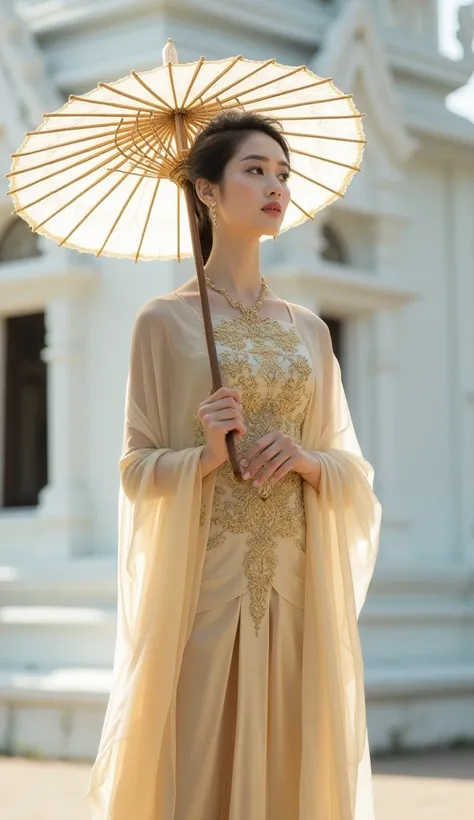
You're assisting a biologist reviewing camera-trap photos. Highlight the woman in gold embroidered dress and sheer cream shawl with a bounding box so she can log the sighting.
[89,112,380,820]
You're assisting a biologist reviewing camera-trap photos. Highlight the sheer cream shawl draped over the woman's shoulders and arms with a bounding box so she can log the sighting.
[88,294,380,820]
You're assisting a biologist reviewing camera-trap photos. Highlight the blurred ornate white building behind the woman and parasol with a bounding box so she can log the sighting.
[0,0,474,820]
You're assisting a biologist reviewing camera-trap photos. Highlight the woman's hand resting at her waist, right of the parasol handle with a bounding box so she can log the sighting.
[240,430,321,489]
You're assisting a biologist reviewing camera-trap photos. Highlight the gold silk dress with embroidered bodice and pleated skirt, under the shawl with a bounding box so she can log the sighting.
[174,315,314,820]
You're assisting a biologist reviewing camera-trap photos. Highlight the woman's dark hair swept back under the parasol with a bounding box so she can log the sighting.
[186,109,290,264]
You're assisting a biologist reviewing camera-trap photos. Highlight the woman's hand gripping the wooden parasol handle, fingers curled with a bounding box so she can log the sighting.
[198,387,245,478]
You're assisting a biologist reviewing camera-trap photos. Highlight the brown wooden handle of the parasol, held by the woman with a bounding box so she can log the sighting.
[175,114,242,480]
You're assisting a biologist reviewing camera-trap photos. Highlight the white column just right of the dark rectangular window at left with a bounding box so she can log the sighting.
[39,294,91,556]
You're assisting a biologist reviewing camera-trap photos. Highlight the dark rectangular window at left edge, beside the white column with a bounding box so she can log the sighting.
[3,313,47,507]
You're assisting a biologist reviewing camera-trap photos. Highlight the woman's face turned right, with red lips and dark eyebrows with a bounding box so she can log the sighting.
[215,131,290,237]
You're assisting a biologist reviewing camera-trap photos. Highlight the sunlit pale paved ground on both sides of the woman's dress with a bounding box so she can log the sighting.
[0,750,474,820]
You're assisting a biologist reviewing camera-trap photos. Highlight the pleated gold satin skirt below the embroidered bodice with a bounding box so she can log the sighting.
[174,587,304,820]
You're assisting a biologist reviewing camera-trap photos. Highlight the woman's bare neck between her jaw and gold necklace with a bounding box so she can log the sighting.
[205,232,262,299]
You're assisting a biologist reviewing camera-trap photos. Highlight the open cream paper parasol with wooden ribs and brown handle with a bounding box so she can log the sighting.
[7,40,366,478]
